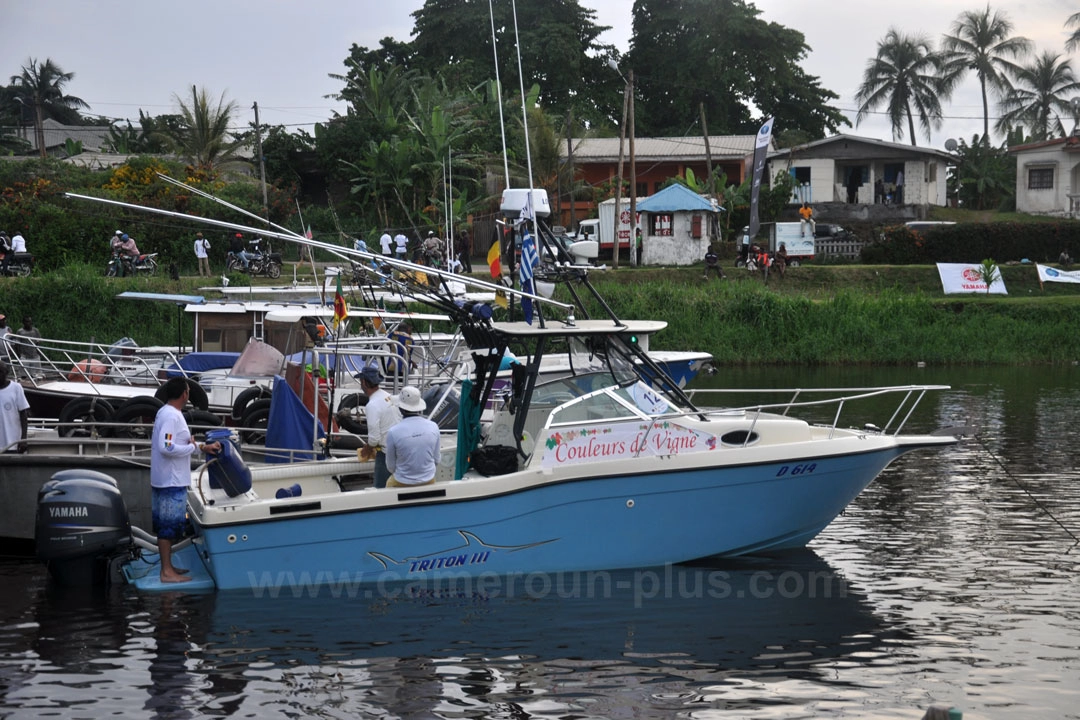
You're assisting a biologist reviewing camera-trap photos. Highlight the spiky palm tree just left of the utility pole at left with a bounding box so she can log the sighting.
[171,85,247,177]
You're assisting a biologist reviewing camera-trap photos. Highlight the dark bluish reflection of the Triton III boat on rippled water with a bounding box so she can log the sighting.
[120,551,881,717]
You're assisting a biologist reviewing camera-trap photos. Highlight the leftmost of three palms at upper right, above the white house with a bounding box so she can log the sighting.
[855,28,953,145]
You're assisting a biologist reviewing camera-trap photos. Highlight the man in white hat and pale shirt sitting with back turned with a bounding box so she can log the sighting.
[387,385,442,488]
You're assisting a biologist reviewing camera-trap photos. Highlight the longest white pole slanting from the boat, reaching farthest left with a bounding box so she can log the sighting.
[65,192,575,320]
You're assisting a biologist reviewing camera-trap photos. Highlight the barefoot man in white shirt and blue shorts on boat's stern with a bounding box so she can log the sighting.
[150,378,221,583]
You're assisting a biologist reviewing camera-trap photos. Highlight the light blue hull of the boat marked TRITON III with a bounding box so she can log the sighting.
[179,446,914,595]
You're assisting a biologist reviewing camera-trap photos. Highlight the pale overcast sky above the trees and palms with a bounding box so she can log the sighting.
[0,0,1080,148]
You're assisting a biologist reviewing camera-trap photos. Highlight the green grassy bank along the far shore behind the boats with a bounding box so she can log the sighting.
[8,266,1080,365]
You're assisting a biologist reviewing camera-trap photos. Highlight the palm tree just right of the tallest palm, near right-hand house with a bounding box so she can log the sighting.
[995,51,1080,140]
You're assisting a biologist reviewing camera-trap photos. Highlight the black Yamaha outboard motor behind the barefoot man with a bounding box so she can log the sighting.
[35,470,132,585]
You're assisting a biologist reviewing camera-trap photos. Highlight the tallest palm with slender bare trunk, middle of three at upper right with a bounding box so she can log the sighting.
[942,5,1031,145]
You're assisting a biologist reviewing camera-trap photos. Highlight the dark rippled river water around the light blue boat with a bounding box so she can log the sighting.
[0,367,1080,719]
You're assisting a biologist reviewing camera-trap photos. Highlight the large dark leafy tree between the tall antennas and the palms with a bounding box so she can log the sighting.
[630,0,850,138]
